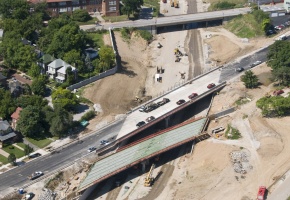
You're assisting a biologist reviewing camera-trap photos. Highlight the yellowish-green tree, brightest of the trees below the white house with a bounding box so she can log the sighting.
[51,88,78,111]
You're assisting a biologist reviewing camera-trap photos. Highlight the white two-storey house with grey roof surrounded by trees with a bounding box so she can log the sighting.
[46,59,77,83]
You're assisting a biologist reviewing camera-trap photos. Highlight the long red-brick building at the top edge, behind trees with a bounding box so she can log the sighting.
[28,0,120,16]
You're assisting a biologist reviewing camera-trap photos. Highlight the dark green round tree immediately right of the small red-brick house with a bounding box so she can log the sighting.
[16,105,44,138]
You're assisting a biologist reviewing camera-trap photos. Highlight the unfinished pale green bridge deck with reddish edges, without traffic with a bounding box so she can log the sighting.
[79,118,207,191]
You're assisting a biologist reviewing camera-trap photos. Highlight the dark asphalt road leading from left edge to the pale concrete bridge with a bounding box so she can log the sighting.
[0,120,124,197]
